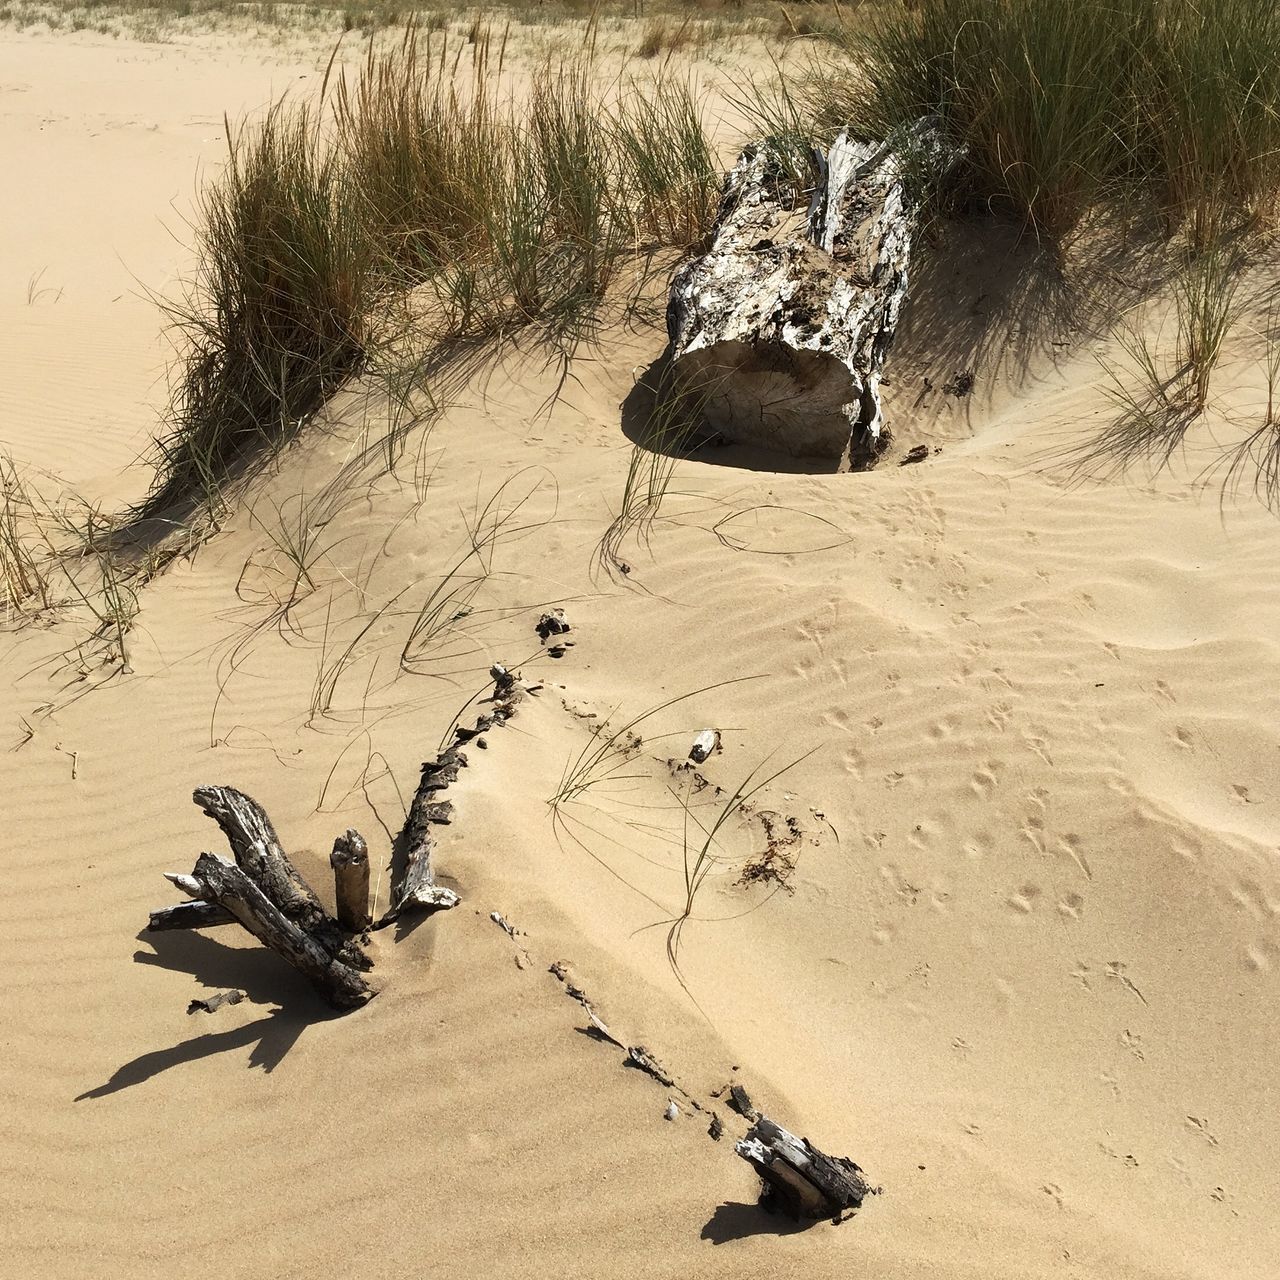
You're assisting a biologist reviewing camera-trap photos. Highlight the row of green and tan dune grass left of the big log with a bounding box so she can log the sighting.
[136,24,719,522]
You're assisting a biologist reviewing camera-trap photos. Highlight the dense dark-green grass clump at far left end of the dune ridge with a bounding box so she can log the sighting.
[140,104,372,517]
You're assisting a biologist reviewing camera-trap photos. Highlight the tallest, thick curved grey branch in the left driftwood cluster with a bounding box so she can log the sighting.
[179,786,362,964]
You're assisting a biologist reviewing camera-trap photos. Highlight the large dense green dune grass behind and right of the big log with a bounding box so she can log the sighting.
[809,0,1280,244]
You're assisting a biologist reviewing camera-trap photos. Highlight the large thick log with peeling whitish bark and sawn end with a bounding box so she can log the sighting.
[667,120,940,468]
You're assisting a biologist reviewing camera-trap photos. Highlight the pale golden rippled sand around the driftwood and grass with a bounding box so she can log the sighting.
[0,20,1280,1280]
